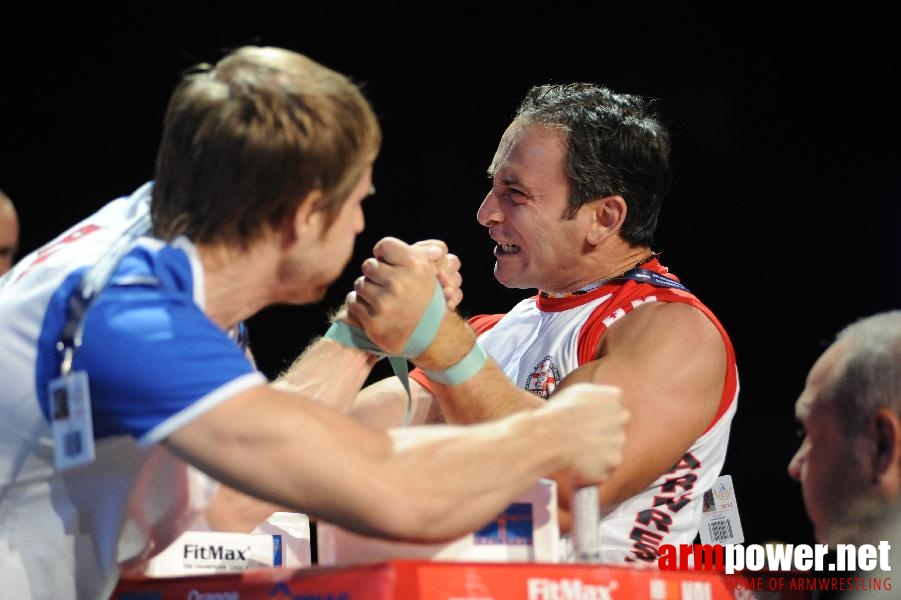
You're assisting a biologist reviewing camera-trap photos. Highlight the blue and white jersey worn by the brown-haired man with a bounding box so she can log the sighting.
[0,184,266,598]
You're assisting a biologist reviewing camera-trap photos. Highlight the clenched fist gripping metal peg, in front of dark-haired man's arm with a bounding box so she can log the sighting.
[539,383,629,485]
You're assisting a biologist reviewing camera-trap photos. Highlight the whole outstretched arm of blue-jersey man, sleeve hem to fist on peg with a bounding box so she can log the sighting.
[165,386,626,541]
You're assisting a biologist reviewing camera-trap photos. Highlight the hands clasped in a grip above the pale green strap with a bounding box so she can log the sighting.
[347,237,454,354]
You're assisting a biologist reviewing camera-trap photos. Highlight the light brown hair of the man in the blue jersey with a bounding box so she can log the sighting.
[152,47,381,248]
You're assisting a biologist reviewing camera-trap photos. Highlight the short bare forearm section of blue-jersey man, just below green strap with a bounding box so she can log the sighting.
[272,339,377,413]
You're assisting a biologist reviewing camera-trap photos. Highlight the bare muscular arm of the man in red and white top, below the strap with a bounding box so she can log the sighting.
[420,303,726,527]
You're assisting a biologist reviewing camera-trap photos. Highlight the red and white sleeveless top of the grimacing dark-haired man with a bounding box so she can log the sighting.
[414,259,738,565]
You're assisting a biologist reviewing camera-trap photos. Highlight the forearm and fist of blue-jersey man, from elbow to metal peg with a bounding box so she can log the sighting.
[376,385,628,535]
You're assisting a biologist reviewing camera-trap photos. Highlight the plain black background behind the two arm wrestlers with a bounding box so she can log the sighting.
[0,9,901,543]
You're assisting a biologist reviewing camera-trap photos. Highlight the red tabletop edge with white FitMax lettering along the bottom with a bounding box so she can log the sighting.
[112,560,824,600]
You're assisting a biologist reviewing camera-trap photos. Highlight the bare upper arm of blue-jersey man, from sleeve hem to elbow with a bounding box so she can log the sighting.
[166,386,391,528]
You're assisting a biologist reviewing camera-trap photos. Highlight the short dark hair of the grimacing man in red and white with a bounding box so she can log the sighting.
[516,83,672,246]
